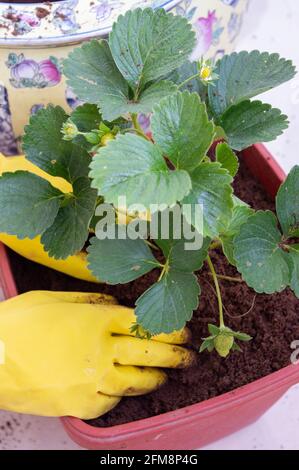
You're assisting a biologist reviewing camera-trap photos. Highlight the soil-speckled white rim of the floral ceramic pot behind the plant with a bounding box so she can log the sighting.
[0,0,180,48]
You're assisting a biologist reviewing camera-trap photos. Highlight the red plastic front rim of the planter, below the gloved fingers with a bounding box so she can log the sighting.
[60,364,299,442]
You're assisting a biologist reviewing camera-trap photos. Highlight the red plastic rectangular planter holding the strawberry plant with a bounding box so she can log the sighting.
[0,145,299,450]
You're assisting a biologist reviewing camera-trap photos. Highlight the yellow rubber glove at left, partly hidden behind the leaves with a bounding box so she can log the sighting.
[0,154,99,283]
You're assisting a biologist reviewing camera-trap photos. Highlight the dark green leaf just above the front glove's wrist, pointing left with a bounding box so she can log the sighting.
[87,237,159,284]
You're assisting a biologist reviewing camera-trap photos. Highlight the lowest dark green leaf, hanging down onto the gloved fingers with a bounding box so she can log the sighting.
[135,270,200,335]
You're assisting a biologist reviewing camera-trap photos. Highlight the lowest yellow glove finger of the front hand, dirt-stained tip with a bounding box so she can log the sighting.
[98,364,167,397]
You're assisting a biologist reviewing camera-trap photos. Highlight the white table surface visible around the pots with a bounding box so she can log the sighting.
[0,0,299,450]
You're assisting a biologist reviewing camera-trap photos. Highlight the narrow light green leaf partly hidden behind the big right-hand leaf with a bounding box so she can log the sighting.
[220,205,254,266]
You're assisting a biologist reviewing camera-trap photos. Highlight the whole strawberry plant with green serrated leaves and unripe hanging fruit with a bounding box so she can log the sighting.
[0,9,299,357]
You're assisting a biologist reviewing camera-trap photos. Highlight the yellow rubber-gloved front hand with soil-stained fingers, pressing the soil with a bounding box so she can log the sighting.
[0,291,193,419]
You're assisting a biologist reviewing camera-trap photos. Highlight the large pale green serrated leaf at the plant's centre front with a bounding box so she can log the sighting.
[90,134,191,208]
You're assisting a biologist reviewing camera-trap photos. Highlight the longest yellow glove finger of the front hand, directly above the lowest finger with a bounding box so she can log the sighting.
[114,336,195,369]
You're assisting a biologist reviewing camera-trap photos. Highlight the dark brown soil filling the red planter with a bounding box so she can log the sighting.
[10,157,299,426]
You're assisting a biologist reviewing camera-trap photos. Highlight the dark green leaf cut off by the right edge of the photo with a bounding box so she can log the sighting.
[276,166,299,238]
